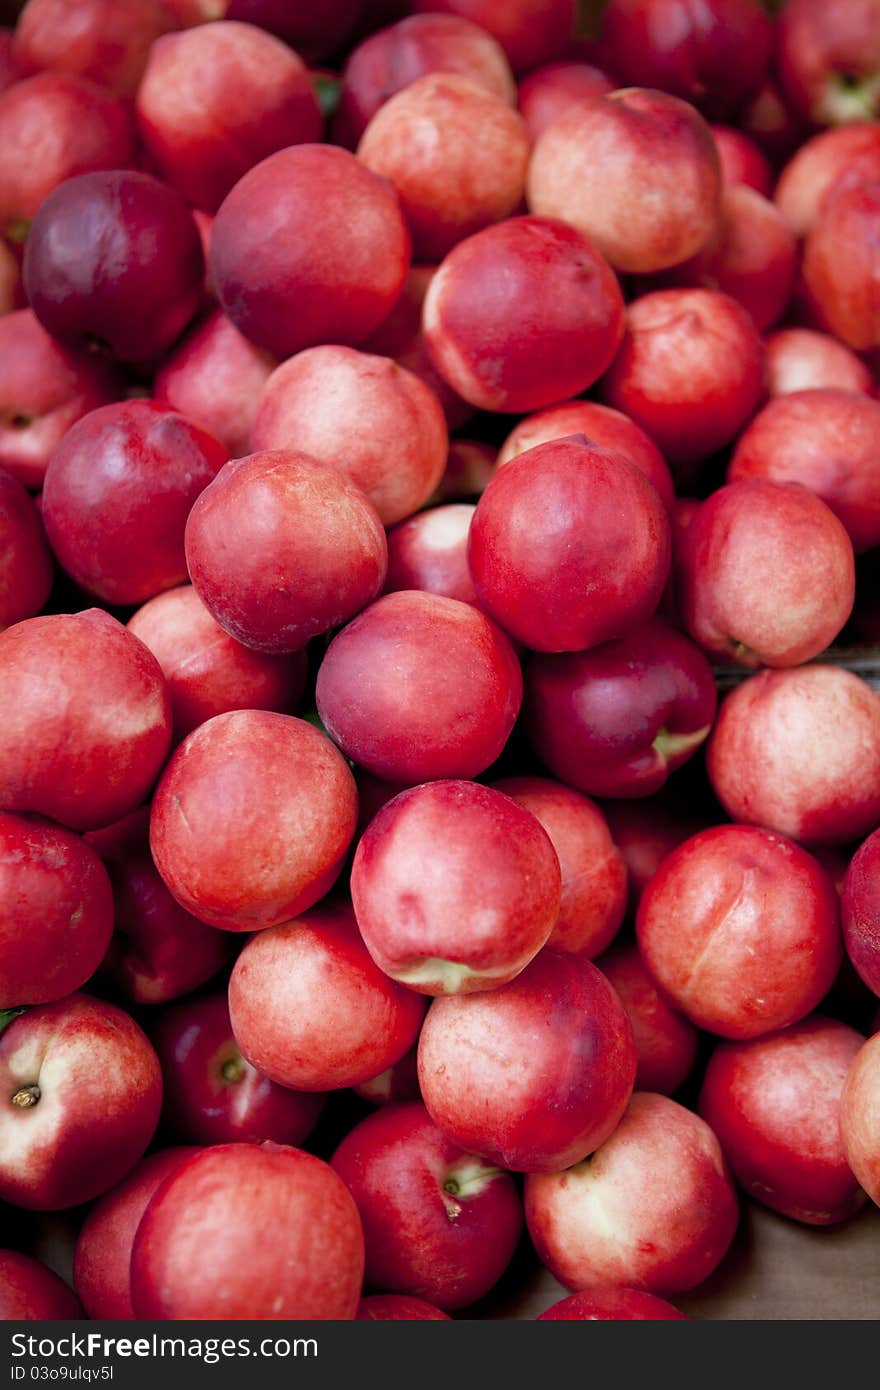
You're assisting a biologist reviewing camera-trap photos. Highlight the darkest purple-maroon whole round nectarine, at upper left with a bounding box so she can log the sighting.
[24,171,204,361]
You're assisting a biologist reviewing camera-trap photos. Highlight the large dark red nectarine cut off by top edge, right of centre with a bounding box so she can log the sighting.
[602,0,773,115]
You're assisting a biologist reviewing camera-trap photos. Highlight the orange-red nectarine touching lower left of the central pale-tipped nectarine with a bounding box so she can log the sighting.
[229,901,425,1091]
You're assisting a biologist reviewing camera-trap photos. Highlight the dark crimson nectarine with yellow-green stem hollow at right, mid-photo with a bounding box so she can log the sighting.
[524,620,717,796]
